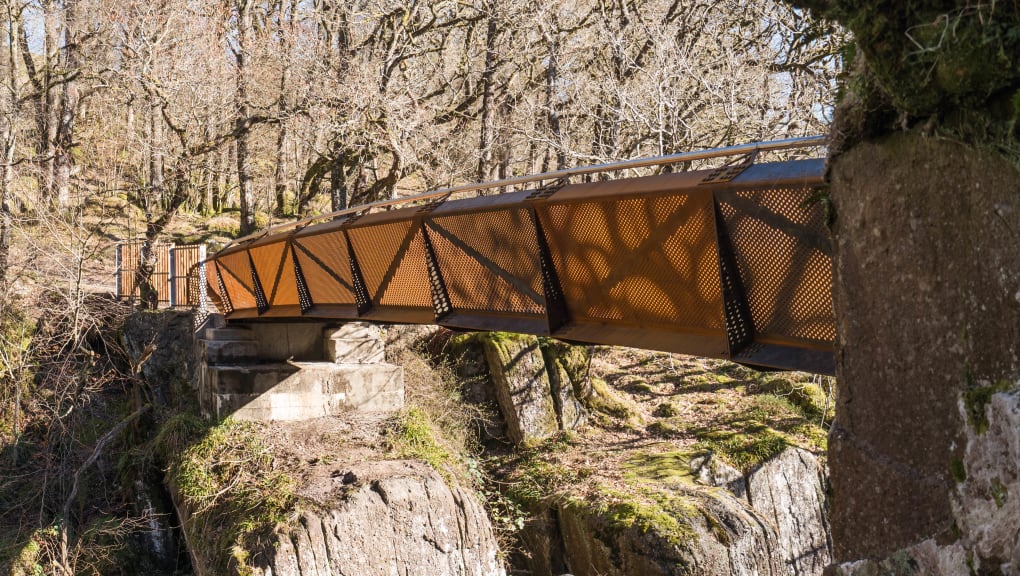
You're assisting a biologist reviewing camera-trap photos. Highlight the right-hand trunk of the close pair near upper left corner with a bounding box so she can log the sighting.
[53,0,81,208]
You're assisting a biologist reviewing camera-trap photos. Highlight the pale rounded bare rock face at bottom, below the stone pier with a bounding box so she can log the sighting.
[250,462,505,576]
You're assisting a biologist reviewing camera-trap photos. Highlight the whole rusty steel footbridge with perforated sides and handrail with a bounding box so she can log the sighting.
[200,138,835,374]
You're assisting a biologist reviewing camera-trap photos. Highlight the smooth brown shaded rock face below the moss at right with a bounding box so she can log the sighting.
[828,134,1020,562]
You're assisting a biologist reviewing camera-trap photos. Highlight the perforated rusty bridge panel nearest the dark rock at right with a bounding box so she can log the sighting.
[720,189,835,343]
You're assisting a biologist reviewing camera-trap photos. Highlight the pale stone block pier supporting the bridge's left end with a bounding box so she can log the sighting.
[197,316,404,421]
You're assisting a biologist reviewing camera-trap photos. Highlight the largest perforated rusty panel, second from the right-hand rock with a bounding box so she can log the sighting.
[540,193,725,331]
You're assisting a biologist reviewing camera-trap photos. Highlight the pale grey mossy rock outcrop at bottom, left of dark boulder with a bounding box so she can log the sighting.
[523,449,831,576]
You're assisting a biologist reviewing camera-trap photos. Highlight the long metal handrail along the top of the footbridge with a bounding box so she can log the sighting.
[221,136,827,251]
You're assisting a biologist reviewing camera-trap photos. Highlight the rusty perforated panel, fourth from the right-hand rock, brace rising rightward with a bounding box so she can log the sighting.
[348,220,432,309]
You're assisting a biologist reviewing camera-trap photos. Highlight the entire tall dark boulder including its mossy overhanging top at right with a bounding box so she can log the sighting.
[793,0,1020,565]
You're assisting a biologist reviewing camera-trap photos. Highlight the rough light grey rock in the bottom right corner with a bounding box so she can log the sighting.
[828,381,1020,576]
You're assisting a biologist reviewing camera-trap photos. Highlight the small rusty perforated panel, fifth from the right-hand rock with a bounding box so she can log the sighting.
[294,230,355,305]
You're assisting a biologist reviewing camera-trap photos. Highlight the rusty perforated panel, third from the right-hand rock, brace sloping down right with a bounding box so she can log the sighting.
[428,209,545,315]
